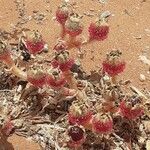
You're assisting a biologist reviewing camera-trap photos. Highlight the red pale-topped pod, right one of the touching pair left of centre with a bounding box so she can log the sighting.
[46,69,66,90]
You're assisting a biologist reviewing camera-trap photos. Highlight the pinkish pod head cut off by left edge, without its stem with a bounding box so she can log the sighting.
[0,40,12,64]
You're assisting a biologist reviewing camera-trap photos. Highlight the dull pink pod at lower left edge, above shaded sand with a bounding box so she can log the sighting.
[1,120,14,136]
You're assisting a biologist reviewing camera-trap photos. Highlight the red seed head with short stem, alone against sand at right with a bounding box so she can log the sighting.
[102,50,125,84]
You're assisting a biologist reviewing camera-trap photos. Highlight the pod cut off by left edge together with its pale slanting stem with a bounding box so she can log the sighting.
[0,40,27,80]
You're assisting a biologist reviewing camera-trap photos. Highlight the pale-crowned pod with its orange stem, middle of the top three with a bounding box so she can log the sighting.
[65,13,83,47]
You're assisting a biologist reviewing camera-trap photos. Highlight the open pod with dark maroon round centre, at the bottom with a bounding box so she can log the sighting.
[67,125,86,148]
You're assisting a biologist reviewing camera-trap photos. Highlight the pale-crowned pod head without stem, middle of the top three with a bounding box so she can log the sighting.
[65,13,83,37]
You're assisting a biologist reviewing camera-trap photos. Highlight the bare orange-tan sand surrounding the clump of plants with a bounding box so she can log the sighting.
[0,0,150,150]
